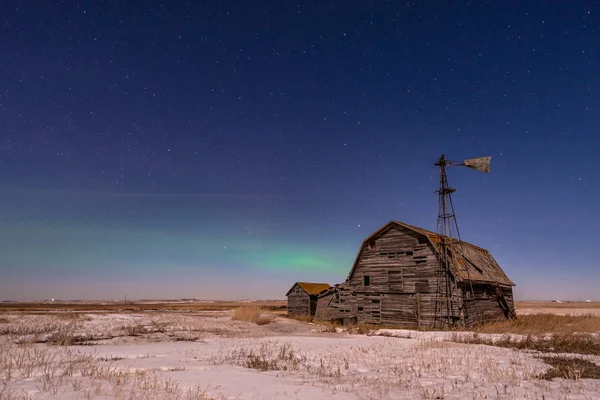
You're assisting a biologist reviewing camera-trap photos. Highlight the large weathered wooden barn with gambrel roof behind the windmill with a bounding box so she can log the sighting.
[315,221,515,327]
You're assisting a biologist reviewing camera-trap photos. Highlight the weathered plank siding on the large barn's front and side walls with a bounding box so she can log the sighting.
[316,226,514,327]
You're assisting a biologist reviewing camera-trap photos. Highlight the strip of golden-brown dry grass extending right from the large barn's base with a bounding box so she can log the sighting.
[476,314,600,335]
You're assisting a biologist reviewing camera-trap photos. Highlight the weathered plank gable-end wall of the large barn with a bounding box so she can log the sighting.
[317,227,461,327]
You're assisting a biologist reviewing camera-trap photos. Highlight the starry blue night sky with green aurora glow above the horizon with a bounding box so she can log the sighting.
[0,0,600,300]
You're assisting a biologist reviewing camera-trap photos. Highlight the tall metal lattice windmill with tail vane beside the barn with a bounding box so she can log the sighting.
[434,154,492,326]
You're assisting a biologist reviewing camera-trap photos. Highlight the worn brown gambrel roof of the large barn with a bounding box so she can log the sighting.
[349,221,515,286]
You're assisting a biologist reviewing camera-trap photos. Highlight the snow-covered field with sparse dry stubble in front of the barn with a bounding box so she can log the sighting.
[0,311,600,400]
